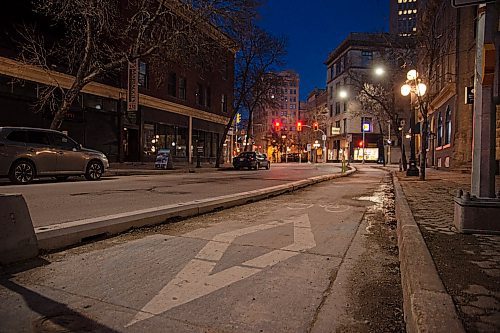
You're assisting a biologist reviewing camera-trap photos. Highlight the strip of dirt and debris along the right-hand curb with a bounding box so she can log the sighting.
[341,177,405,332]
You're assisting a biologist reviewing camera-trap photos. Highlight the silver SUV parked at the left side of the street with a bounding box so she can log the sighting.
[0,127,109,184]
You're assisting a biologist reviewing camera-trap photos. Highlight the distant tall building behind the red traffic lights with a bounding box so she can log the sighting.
[253,70,300,160]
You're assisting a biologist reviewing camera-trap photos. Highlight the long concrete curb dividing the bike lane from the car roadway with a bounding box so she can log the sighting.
[35,167,357,250]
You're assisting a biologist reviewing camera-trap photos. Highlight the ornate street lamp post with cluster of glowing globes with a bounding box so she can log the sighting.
[401,69,427,178]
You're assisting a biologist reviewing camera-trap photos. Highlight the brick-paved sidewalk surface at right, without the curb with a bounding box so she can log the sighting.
[390,167,500,332]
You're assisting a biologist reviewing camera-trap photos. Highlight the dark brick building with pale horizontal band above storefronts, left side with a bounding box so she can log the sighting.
[0,0,234,162]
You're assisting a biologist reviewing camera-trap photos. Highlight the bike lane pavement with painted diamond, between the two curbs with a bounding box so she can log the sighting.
[0,167,404,332]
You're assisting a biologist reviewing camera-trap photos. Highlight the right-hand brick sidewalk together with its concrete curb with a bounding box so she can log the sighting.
[387,167,500,332]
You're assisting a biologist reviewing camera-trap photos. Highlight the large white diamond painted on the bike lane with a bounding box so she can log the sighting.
[125,214,316,327]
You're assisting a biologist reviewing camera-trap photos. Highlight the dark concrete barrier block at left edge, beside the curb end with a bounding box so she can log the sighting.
[0,194,38,265]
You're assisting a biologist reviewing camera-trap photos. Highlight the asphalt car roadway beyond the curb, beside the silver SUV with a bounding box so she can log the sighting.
[0,164,340,227]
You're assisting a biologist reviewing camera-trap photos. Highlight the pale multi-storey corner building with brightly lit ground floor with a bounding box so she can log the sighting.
[325,33,400,161]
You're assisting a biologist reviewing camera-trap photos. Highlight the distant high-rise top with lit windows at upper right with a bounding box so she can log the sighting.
[389,0,418,36]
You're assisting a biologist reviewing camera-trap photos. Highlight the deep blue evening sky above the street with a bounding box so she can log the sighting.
[260,0,389,101]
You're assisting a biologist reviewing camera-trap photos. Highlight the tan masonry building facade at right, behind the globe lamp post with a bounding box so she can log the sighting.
[417,1,477,169]
